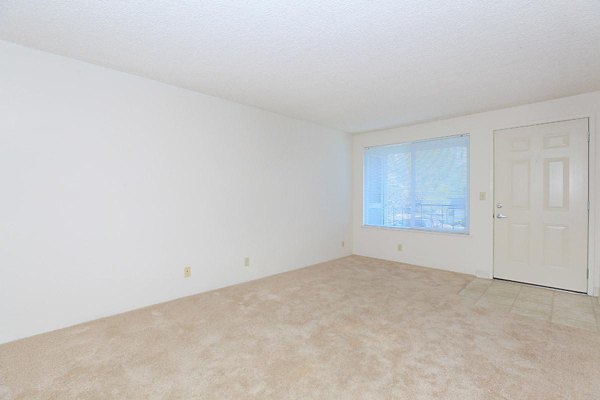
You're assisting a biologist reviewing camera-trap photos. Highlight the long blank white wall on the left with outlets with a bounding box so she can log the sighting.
[0,42,352,342]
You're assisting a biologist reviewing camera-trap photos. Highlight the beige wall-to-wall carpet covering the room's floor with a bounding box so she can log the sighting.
[0,256,600,400]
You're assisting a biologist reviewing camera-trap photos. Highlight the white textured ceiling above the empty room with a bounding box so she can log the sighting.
[0,0,600,132]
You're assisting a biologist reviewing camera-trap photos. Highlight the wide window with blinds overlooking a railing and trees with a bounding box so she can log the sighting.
[363,135,469,233]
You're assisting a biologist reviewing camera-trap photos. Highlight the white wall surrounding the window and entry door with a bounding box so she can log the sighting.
[353,92,600,295]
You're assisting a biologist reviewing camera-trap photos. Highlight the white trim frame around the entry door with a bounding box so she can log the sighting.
[491,115,600,294]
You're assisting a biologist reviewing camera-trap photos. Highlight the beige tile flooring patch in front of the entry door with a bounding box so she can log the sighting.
[459,278,600,332]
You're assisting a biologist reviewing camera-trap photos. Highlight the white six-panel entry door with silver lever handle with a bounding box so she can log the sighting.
[494,118,589,292]
